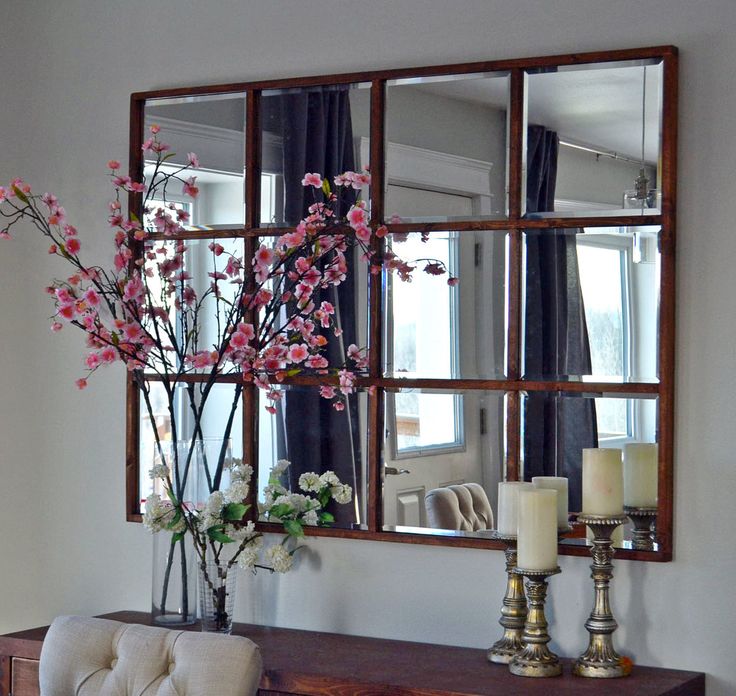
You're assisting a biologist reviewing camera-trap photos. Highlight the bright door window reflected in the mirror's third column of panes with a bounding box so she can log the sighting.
[387,232,463,456]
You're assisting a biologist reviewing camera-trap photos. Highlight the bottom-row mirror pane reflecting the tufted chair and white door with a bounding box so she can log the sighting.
[383,389,505,536]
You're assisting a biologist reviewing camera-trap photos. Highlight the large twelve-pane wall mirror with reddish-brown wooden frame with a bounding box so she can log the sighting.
[128,47,677,560]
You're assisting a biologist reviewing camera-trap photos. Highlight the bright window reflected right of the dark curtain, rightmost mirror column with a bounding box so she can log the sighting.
[577,231,633,441]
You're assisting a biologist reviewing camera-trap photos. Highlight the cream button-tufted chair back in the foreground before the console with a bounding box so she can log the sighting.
[39,616,263,696]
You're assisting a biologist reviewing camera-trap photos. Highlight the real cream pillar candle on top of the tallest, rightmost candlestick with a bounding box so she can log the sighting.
[583,448,624,515]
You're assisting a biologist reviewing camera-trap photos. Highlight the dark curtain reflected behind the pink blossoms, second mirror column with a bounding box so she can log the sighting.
[280,86,362,527]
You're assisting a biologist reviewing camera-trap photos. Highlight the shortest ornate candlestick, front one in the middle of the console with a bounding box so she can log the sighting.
[509,567,562,677]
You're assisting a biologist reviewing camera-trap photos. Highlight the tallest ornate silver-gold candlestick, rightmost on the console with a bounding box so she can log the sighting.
[573,513,630,679]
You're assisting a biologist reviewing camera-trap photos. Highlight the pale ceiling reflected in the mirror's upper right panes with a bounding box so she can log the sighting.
[416,64,662,163]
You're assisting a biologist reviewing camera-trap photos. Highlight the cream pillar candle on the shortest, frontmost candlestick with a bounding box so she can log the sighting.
[516,488,557,570]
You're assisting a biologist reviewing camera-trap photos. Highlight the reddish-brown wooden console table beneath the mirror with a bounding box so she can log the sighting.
[0,611,705,696]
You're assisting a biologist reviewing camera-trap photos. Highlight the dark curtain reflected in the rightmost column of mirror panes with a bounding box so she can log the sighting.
[524,126,598,511]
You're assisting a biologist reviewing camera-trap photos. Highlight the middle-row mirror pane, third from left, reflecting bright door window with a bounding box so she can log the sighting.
[384,230,508,379]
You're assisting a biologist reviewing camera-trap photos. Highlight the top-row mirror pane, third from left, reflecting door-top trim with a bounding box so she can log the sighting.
[385,73,509,222]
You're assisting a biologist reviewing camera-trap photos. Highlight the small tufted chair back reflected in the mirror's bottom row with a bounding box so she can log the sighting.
[424,483,493,532]
